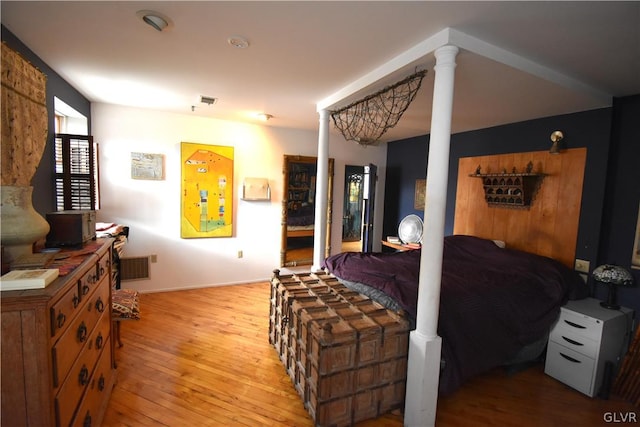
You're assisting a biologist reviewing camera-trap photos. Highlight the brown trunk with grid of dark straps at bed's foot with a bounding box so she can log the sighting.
[269,270,409,426]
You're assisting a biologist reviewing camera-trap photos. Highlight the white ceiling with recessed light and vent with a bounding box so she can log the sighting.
[0,0,640,144]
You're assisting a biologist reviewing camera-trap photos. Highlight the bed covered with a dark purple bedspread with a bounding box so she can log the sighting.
[323,235,588,395]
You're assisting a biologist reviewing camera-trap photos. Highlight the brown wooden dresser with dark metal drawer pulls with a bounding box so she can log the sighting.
[0,238,116,427]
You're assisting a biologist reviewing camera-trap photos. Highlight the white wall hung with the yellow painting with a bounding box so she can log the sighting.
[92,104,386,292]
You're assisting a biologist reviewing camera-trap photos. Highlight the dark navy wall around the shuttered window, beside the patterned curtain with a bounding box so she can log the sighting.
[2,25,91,216]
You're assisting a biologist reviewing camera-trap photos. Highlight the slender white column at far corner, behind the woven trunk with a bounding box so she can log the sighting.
[311,110,329,271]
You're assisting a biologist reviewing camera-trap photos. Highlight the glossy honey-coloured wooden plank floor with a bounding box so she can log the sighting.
[103,282,640,427]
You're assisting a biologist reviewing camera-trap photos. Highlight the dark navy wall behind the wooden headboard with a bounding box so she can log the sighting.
[383,97,640,310]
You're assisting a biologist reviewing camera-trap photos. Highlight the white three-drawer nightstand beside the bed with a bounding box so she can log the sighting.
[544,298,633,397]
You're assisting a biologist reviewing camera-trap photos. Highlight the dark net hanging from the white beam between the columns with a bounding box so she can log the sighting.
[331,70,427,145]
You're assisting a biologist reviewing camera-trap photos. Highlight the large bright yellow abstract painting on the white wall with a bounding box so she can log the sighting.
[180,142,233,238]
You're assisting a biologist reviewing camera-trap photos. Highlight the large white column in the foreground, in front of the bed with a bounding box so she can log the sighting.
[404,46,458,427]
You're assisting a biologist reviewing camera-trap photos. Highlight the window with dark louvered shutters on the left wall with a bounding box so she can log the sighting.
[55,133,100,211]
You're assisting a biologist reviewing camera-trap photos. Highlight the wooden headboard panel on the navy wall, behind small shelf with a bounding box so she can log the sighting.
[453,148,587,268]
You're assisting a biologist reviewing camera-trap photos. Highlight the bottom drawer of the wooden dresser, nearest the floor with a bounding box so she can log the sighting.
[72,339,114,427]
